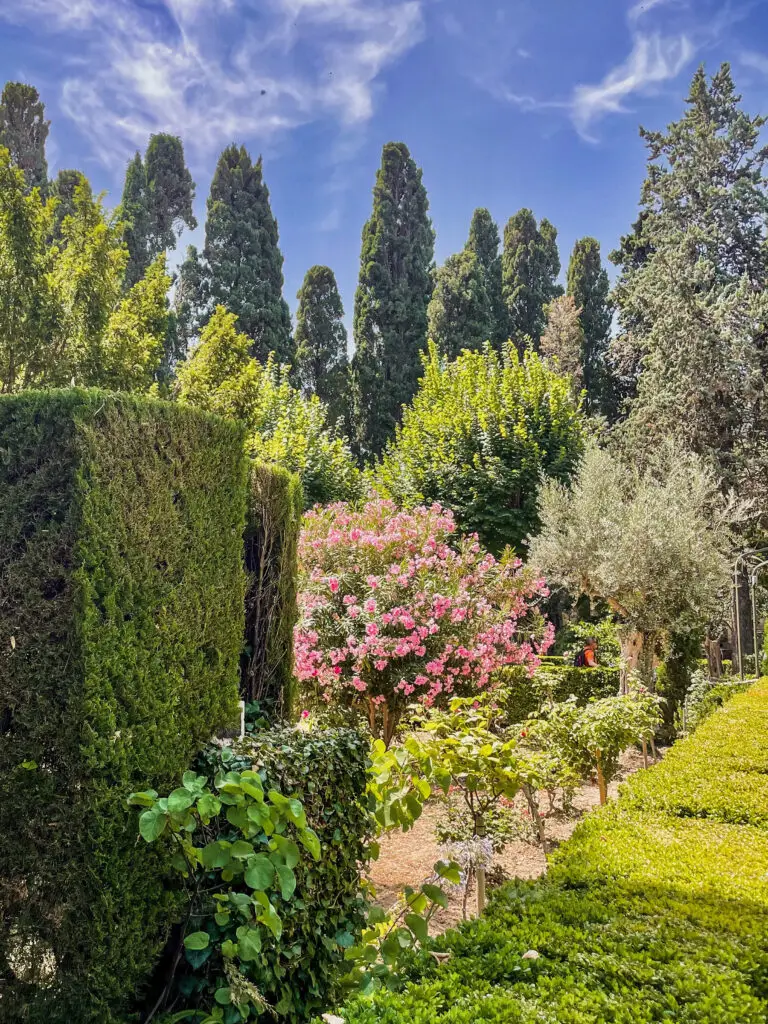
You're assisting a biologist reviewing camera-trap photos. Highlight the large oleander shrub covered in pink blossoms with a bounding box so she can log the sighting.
[295,500,552,743]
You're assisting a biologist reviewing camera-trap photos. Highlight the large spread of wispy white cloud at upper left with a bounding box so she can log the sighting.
[0,0,423,167]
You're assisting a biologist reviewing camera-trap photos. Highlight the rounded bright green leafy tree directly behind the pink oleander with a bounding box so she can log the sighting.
[377,344,584,552]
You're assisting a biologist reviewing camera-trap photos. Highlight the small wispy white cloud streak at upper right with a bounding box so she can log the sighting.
[568,33,695,138]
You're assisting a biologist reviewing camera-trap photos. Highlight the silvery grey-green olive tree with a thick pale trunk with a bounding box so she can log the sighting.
[530,445,739,686]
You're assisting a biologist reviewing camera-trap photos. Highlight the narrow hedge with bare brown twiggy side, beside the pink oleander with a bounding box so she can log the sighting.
[241,463,304,719]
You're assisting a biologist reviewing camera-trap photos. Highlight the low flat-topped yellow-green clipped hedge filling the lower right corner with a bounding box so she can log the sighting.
[331,682,768,1024]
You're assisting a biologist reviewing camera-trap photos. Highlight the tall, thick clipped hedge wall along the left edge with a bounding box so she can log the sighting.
[0,390,246,1024]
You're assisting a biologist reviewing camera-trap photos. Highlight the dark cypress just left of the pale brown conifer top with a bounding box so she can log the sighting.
[502,209,562,348]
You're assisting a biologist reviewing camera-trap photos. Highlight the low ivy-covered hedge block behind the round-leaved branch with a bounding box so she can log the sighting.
[143,729,373,1022]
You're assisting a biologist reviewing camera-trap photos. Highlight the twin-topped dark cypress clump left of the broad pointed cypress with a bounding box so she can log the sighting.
[120,134,198,288]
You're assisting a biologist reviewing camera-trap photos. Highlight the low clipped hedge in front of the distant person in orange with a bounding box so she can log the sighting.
[494,663,620,722]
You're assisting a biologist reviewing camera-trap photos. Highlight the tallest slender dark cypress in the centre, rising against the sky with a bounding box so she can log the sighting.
[352,142,434,456]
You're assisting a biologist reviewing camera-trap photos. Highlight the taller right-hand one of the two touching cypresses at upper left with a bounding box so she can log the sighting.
[144,134,198,260]
